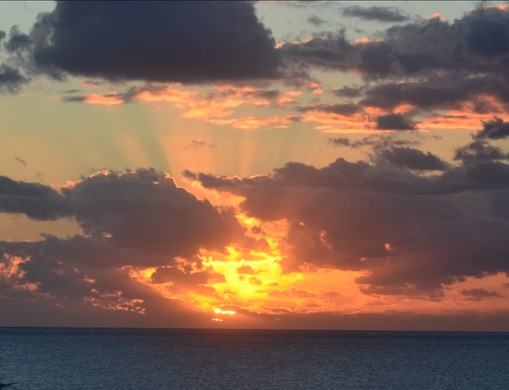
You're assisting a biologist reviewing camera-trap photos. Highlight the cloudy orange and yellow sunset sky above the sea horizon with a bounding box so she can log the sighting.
[0,1,509,331]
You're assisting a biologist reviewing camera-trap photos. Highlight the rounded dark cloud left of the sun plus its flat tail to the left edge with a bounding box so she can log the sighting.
[0,169,241,256]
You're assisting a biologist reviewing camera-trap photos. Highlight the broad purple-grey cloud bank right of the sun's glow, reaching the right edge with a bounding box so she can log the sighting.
[189,148,509,299]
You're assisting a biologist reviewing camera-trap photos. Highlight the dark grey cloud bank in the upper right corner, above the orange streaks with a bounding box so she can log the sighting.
[278,6,509,122]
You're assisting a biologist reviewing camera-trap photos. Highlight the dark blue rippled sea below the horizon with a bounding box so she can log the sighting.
[0,328,509,390]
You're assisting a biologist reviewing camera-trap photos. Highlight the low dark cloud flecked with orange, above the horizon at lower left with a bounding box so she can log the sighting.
[0,236,212,326]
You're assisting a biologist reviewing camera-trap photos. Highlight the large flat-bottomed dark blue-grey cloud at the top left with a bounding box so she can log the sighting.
[5,1,279,83]
